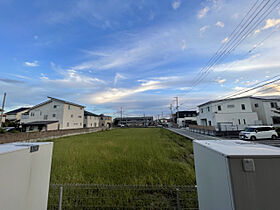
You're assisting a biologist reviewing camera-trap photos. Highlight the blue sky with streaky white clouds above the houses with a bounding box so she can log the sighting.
[0,0,280,117]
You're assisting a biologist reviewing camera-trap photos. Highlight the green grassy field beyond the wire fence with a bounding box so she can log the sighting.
[51,128,195,185]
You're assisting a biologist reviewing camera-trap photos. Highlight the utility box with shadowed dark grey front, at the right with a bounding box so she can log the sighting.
[193,140,280,210]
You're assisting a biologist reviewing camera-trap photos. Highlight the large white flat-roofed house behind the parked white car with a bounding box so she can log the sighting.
[198,96,280,130]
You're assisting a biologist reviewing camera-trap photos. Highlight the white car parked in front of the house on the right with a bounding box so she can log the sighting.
[239,126,278,141]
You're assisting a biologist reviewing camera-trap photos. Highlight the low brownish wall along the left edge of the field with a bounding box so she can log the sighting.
[0,127,108,144]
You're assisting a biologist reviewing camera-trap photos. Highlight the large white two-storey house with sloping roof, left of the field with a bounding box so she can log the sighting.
[21,97,85,130]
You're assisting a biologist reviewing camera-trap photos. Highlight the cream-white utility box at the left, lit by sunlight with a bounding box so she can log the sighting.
[0,142,53,210]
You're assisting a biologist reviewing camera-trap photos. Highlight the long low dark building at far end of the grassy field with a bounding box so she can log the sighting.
[114,116,154,127]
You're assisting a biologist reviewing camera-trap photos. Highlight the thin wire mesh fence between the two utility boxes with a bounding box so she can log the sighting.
[48,184,198,210]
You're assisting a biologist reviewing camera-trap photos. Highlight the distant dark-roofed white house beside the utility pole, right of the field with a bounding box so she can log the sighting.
[174,111,197,127]
